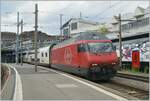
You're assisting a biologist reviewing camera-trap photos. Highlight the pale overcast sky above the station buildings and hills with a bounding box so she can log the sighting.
[1,0,149,35]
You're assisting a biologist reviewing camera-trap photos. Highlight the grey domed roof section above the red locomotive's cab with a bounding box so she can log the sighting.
[73,32,108,41]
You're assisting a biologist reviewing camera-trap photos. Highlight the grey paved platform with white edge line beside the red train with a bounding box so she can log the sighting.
[7,64,126,100]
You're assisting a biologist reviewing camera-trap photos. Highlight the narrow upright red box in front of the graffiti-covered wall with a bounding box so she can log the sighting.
[132,50,140,69]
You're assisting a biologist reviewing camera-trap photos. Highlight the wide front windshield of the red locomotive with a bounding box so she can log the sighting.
[88,42,113,53]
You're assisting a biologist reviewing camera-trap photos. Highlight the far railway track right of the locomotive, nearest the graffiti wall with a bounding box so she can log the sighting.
[116,73,149,83]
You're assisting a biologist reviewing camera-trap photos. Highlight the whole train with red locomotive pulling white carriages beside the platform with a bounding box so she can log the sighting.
[24,32,118,80]
